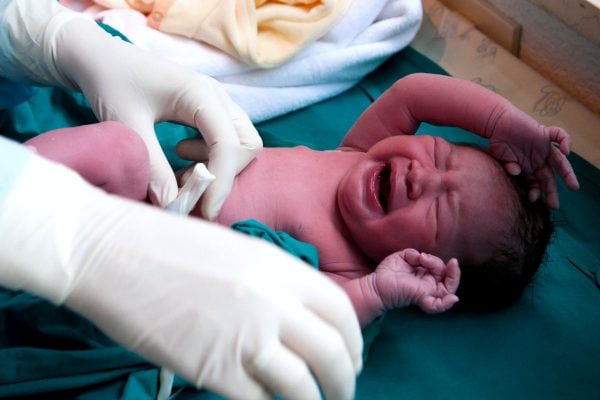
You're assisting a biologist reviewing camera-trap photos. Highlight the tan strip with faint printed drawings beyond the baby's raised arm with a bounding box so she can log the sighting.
[412,0,600,168]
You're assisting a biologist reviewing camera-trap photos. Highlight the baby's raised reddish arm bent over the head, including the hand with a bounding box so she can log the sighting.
[340,73,579,207]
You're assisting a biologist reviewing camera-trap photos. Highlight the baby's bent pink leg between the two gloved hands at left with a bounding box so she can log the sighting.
[25,122,150,200]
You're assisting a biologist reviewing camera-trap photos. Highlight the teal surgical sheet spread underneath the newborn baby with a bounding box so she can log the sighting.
[0,48,600,400]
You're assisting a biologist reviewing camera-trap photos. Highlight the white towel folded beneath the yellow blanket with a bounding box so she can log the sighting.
[62,0,422,122]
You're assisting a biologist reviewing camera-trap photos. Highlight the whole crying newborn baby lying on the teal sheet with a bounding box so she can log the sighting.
[28,74,577,326]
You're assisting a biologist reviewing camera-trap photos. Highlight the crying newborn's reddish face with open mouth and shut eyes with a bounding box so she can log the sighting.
[337,136,511,262]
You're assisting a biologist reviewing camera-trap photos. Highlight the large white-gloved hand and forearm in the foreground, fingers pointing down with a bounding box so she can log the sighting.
[0,138,362,399]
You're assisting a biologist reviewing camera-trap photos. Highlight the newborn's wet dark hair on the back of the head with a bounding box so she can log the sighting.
[456,145,554,312]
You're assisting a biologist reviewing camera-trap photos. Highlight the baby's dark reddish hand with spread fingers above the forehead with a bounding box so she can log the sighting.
[488,108,579,208]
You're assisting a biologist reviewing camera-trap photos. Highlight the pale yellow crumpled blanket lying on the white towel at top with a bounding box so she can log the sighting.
[94,0,352,68]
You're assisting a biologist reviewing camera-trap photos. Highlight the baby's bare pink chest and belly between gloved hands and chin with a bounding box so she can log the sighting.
[210,147,364,276]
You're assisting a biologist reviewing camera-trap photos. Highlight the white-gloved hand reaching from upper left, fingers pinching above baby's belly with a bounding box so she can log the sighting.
[0,0,262,219]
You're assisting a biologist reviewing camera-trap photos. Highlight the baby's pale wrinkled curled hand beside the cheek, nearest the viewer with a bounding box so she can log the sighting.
[374,249,460,313]
